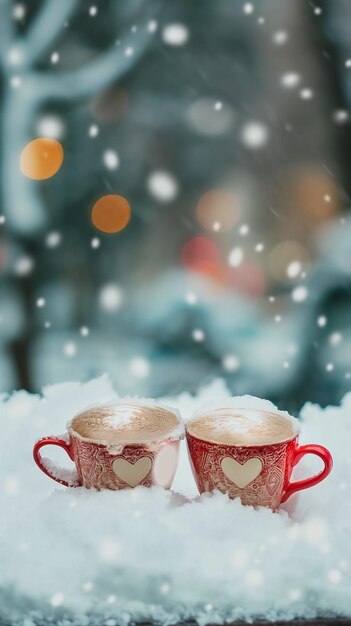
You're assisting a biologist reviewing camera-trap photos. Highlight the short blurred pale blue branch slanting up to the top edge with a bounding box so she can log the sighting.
[23,0,77,68]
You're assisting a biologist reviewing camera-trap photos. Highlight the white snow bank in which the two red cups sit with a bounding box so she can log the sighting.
[0,376,351,626]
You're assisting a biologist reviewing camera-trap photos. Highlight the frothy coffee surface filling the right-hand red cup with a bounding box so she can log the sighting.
[186,407,296,446]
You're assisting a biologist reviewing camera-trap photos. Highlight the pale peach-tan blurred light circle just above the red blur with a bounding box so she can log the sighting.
[196,189,240,232]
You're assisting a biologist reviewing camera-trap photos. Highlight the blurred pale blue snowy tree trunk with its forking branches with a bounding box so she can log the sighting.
[1,0,159,236]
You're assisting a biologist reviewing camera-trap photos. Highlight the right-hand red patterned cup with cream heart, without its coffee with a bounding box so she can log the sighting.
[186,408,333,510]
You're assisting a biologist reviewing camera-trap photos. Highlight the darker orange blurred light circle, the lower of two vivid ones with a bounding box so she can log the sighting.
[91,194,131,233]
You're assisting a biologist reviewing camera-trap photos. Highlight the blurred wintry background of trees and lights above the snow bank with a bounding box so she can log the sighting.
[0,0,351,410]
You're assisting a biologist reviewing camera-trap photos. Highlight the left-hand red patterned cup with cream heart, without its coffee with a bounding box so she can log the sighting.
[33,400,183,490]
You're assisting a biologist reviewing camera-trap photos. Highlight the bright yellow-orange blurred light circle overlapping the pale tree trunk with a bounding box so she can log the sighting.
[20,137,63,180]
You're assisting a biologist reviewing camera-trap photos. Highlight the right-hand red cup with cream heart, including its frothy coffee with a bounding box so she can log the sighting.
[186,398,332,510]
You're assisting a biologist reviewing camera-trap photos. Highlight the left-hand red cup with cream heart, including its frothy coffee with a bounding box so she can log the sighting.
[33,398,184,490]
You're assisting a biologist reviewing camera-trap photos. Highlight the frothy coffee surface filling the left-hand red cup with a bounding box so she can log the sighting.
[71,401,180,443]
